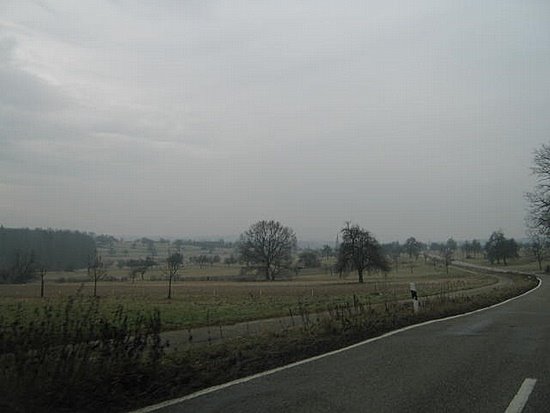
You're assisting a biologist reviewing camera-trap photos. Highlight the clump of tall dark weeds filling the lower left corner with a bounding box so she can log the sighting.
[0,296,163,412]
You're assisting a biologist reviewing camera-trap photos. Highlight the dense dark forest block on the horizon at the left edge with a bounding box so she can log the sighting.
[0,226,96,283]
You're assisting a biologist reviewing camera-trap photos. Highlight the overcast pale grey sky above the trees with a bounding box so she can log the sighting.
[0,0,550,241]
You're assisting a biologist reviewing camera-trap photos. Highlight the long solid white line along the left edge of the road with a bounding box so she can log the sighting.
[130,277,542,413]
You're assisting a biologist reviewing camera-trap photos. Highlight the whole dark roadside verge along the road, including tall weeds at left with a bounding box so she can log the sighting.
[0,276,537,412]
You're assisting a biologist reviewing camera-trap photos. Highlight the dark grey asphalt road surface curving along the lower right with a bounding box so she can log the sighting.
[137,274,550,413]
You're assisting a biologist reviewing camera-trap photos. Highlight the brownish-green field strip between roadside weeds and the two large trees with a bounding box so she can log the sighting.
[0,260,496,330]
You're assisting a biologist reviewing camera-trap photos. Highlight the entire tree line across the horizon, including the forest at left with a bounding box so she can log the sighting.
[0,216,547,290]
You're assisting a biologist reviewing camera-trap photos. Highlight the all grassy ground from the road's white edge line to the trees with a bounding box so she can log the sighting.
[0,243,536,411]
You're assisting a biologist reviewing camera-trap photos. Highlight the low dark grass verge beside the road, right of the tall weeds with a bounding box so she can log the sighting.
[126,276,538,407]
